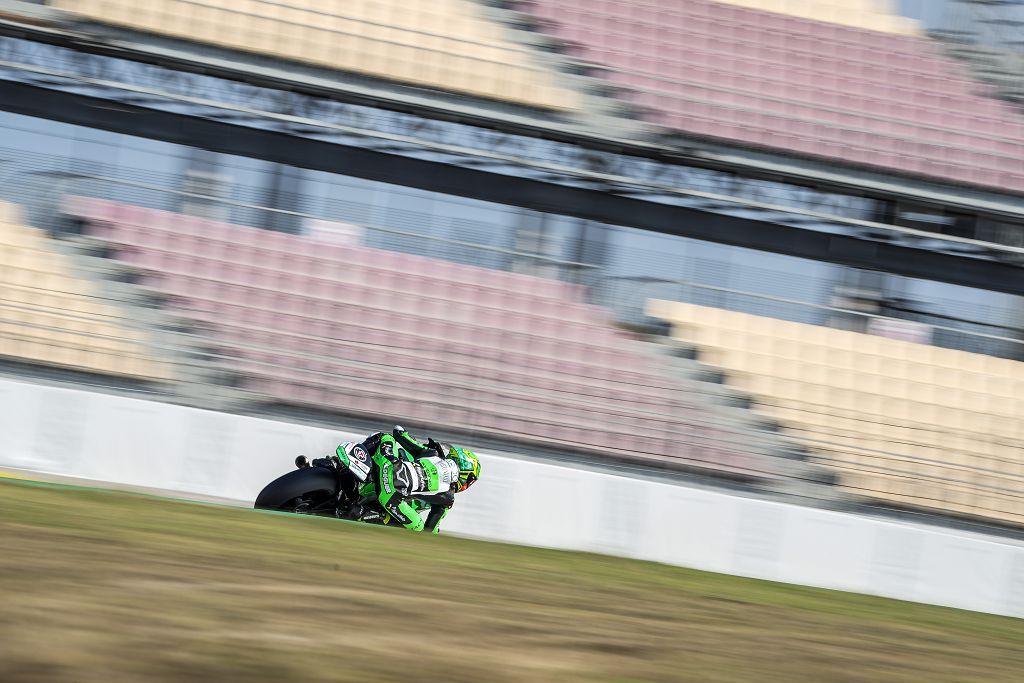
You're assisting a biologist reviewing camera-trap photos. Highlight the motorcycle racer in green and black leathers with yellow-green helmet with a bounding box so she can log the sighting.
[321,425,480,533]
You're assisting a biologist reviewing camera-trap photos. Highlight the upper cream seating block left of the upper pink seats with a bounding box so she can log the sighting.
[53,0,575,110]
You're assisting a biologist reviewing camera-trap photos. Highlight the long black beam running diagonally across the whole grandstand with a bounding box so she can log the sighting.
[0,81,1024,296]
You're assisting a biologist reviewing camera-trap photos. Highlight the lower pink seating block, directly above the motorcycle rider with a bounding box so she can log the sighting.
[67,198,779,479]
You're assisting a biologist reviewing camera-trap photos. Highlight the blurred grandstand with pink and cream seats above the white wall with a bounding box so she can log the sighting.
[0,0,1024,598]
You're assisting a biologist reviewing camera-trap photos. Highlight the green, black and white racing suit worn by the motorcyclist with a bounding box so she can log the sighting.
[339,426,459,533]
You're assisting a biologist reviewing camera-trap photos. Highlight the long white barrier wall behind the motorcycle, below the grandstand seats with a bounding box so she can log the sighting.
[0,380,1024,616]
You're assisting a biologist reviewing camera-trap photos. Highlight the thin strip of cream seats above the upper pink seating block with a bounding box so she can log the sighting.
[718,0,918,35]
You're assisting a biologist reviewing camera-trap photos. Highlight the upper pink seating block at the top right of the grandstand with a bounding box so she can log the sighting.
[521,0,1024,191]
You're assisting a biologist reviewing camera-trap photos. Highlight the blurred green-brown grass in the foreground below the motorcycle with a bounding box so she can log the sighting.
[0,481,1024,683]
